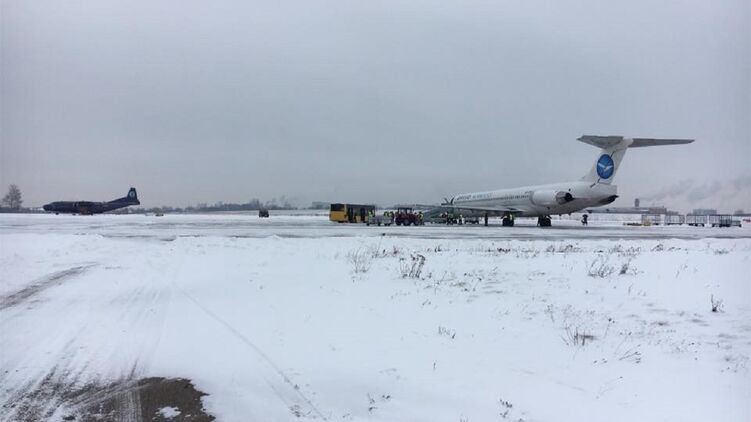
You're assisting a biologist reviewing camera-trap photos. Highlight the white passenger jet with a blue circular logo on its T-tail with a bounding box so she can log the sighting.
[439,135,694,227]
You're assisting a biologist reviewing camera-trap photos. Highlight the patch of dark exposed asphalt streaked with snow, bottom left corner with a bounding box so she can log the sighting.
[0,377,215,422]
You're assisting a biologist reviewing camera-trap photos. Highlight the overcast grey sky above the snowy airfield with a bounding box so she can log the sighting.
[0,0,751,211]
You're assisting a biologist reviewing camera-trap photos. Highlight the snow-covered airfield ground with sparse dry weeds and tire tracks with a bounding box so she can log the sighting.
[0,215,751,422]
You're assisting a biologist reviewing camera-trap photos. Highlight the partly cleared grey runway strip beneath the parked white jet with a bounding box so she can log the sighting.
[0,214,751,240]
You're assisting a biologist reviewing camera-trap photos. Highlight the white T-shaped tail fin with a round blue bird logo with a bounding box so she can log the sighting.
[578,135,694,185]
